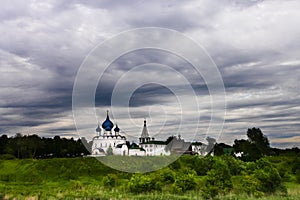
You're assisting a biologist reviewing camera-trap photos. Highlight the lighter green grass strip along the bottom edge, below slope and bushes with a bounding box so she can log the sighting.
[0,181,300,200]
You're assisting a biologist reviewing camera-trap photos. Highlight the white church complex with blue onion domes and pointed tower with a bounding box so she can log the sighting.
[91,111,211,157]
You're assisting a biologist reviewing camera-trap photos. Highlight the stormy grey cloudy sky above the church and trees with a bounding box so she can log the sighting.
[0,0,300,147]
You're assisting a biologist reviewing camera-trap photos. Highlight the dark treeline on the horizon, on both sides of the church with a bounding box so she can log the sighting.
[0,128,300,161]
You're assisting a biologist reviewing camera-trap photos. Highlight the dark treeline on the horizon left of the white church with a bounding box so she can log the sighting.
[0,133,89,159]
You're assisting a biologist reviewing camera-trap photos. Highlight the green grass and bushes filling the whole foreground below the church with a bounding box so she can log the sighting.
[0,155,300,199]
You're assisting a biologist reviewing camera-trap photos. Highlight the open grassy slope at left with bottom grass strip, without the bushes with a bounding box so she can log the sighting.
[0,158,300,200]
